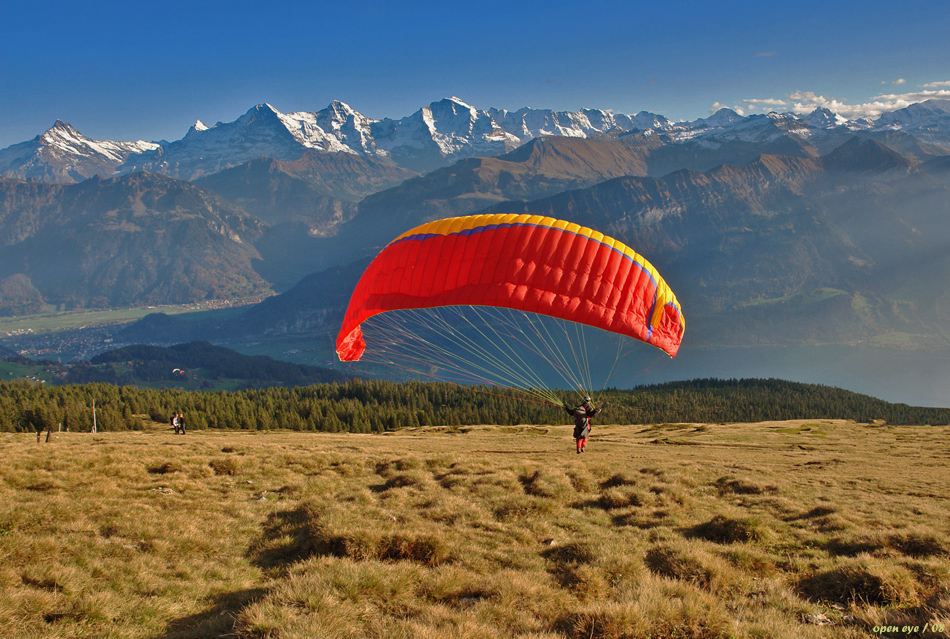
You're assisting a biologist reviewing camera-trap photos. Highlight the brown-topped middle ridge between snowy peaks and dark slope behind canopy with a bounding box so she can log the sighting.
[314,131,928,267]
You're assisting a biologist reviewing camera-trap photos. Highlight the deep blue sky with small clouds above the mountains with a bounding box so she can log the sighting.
[0,0,950,148]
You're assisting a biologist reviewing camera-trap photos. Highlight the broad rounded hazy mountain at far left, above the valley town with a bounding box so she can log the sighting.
[0,173,267,308]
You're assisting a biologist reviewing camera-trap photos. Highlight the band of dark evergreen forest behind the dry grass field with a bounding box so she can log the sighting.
[0,379,950,433]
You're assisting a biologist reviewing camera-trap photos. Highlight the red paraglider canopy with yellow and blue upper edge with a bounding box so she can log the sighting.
[336,214,685,361]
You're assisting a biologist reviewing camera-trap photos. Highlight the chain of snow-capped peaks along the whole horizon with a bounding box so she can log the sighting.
[0,96,950,182]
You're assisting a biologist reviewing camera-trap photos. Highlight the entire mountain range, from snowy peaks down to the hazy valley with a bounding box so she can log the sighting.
[0,98,950,364]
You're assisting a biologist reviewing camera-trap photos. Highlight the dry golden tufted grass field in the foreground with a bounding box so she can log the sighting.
[0,421,950,639]
